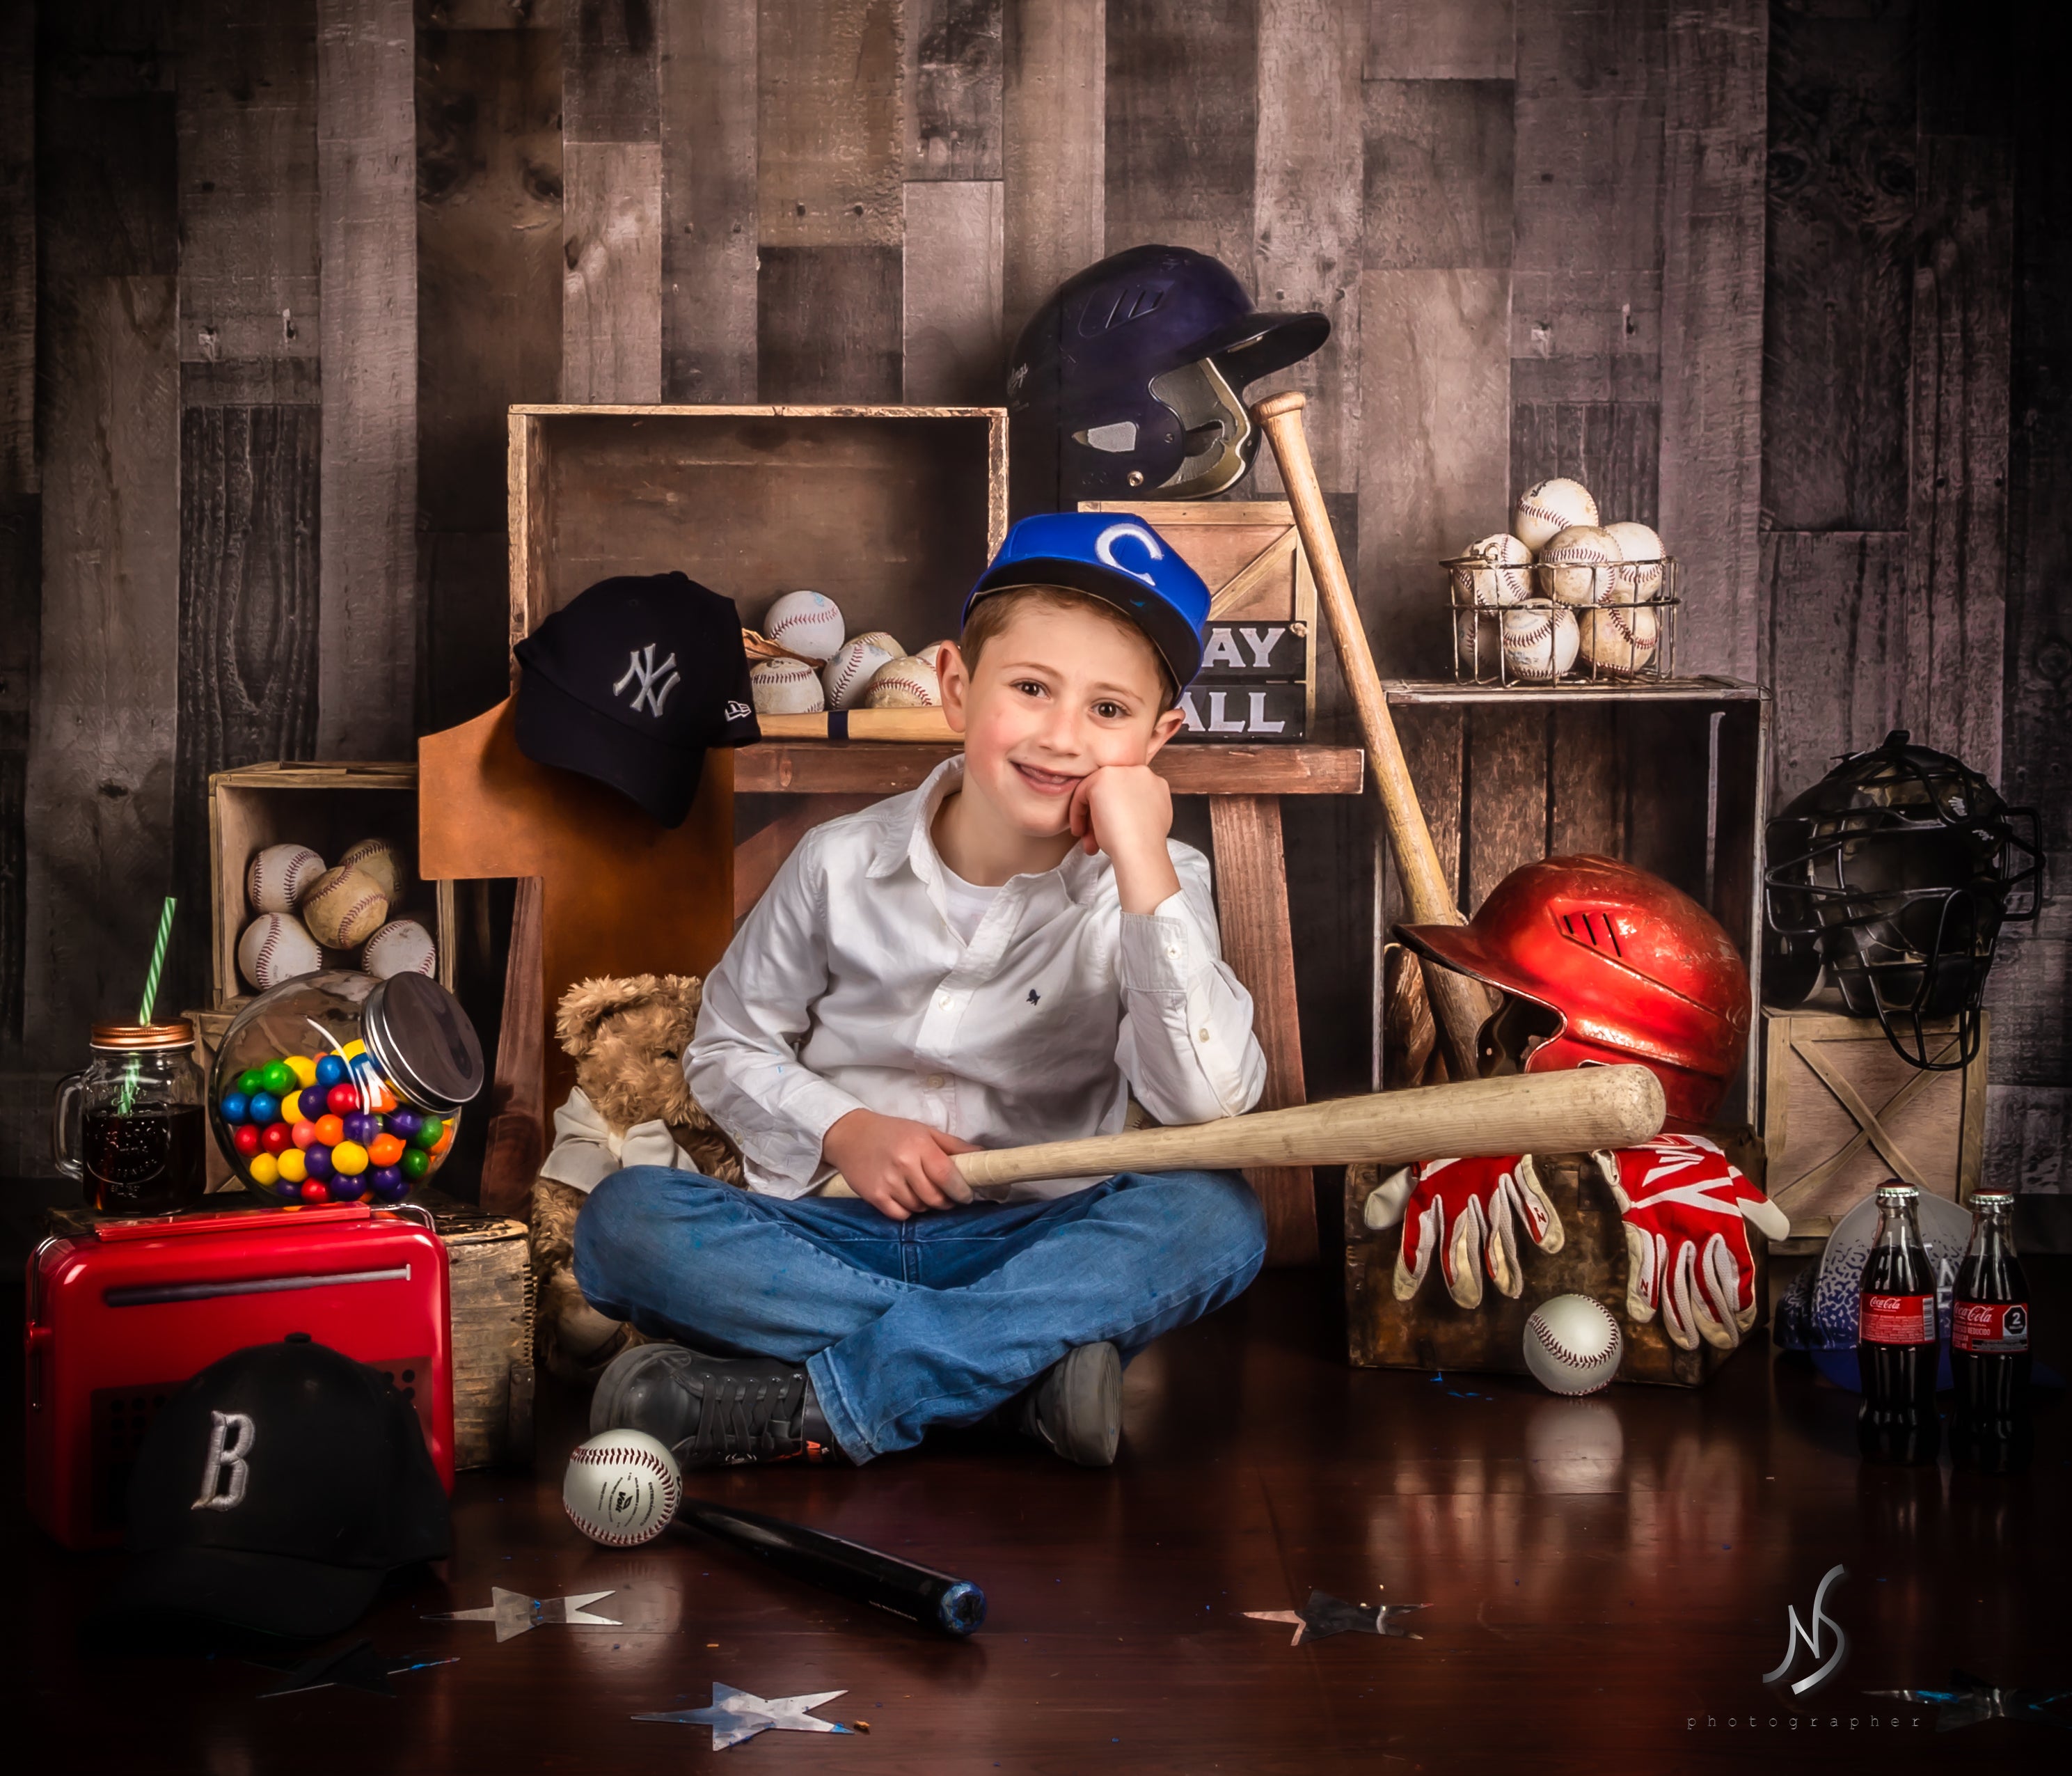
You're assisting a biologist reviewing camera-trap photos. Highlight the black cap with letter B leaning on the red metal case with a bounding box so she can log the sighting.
[95,1333,450,1640]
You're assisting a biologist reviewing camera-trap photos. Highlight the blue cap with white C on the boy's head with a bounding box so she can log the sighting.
[963,512,1208,688]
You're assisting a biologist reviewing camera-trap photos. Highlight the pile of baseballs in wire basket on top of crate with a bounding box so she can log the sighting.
[1453,477,1664,684]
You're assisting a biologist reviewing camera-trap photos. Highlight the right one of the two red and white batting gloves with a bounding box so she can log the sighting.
[1591,1135,1790,1351]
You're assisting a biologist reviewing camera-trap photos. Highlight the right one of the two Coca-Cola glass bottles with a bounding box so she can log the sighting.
[1950,1190,2030,1473]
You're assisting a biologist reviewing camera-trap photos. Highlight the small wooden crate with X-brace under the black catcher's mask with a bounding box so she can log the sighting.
[1763,991,1993,1241]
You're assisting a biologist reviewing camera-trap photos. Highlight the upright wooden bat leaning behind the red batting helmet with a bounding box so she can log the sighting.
[1251,390,1489,1080]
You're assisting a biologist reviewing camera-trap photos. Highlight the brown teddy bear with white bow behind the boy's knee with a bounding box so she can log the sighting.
[532,974,742,1384]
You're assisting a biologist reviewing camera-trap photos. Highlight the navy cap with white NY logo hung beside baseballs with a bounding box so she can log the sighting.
[518,574,763,827]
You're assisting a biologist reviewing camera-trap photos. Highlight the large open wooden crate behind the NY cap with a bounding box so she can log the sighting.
[507,406,1007,663]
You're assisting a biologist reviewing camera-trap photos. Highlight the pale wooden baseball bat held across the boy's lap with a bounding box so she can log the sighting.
[955,1067,1664,1190]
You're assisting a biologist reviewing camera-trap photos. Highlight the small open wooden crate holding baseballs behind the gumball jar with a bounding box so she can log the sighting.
[209,762,456,1009]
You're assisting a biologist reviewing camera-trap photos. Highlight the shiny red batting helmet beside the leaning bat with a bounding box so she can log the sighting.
[1396,858,1749,1123]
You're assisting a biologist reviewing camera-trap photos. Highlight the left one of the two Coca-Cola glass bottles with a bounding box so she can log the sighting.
[1856,1179,1941,1467]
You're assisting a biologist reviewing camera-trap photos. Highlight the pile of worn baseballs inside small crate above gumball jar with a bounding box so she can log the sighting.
[238,840,439,993]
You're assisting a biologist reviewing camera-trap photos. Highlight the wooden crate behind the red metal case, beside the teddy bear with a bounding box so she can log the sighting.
[44,1190,532,1467]
